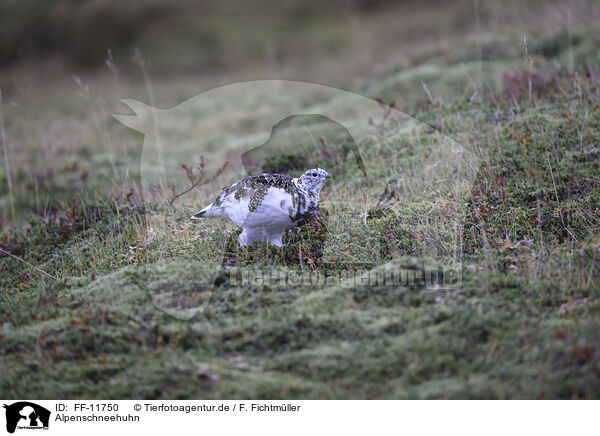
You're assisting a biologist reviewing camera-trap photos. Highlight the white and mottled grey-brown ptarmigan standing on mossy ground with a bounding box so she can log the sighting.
[192,168,331,247]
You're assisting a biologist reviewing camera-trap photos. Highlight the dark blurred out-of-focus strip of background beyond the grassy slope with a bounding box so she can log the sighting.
[0,0,598,84]
